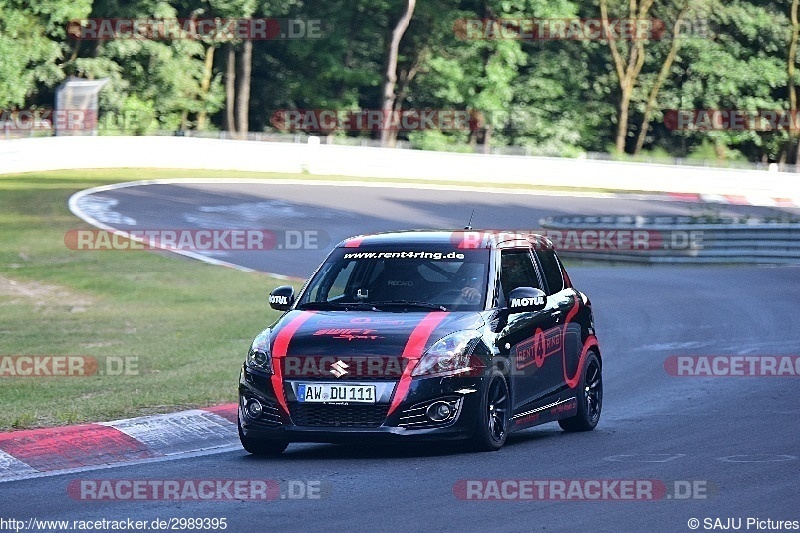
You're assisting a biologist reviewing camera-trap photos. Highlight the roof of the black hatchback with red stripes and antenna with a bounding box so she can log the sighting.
[336,229,552,249]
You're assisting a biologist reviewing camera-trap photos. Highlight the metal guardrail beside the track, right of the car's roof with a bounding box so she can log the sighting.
[540,216,800,265]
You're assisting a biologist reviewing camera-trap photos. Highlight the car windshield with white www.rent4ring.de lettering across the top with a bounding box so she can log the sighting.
[298,247,489,311]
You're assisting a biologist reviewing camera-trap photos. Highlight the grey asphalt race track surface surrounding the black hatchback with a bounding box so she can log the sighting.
[0,183,800,532]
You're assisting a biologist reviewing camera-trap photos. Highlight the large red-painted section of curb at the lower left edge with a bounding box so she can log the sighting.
[0,424,161,472]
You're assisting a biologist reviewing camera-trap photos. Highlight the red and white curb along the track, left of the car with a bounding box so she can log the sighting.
[0,403,240,482]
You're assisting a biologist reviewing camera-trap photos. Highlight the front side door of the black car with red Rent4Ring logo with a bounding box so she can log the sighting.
[498,248,561,413]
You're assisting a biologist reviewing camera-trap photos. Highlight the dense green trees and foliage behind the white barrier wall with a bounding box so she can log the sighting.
[0,0,797,162]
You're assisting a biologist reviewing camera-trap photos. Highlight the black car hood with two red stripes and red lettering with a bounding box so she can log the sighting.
[270,311,484,359]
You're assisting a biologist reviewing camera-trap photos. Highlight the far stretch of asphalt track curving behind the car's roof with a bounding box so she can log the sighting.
[69,180,800,278]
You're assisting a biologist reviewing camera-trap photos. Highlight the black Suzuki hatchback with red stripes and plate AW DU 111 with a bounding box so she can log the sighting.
[239,230,603,455]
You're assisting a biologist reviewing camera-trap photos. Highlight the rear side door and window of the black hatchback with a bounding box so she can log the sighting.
[535,248,581,389]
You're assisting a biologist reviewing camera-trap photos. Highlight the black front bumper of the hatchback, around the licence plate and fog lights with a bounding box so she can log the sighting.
[239,366,483,442]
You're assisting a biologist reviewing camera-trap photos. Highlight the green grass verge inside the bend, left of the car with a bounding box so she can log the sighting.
[0,169,310,431]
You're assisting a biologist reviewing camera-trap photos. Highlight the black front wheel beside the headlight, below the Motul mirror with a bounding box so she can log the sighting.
[470,368,511,452]
